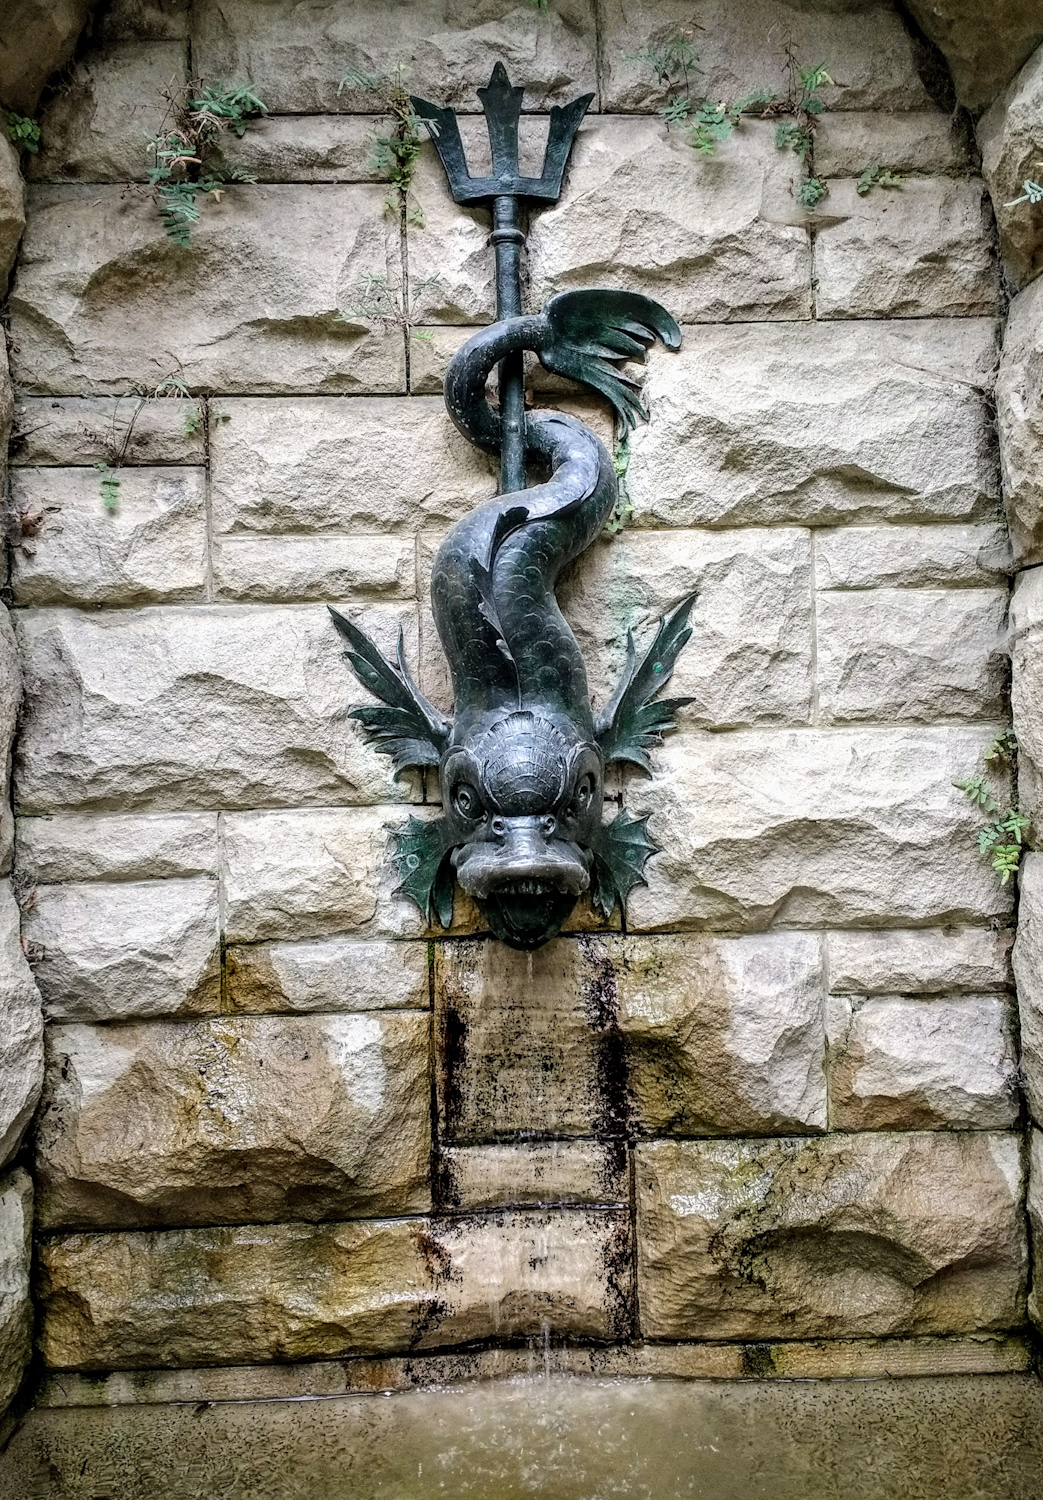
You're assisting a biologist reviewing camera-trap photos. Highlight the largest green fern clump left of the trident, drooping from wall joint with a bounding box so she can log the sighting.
[149,80,267,246]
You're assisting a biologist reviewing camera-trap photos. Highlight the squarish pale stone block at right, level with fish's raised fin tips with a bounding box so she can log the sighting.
[816,588,1010,725]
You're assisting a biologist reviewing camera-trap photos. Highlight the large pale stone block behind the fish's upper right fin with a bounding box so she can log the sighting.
[560,528,812,728]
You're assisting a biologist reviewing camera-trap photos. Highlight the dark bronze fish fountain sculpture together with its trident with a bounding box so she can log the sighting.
[330,63,693,948]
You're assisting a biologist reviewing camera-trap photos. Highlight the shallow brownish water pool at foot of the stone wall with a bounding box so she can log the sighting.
[0,1374,1043,1500]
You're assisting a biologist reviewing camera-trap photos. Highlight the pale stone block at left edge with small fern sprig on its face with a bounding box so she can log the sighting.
[11,468,207,605]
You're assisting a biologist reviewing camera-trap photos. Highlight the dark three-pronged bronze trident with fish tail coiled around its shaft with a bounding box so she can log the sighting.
[411,63,594,495]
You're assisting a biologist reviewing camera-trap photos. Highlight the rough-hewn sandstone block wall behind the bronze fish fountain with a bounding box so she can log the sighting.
[0,0,1043,1404]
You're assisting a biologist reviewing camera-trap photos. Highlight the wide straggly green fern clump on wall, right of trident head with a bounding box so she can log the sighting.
[624,32,833,209]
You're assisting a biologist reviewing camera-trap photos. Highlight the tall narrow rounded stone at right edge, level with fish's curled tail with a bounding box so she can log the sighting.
[996,278,1043,567]
